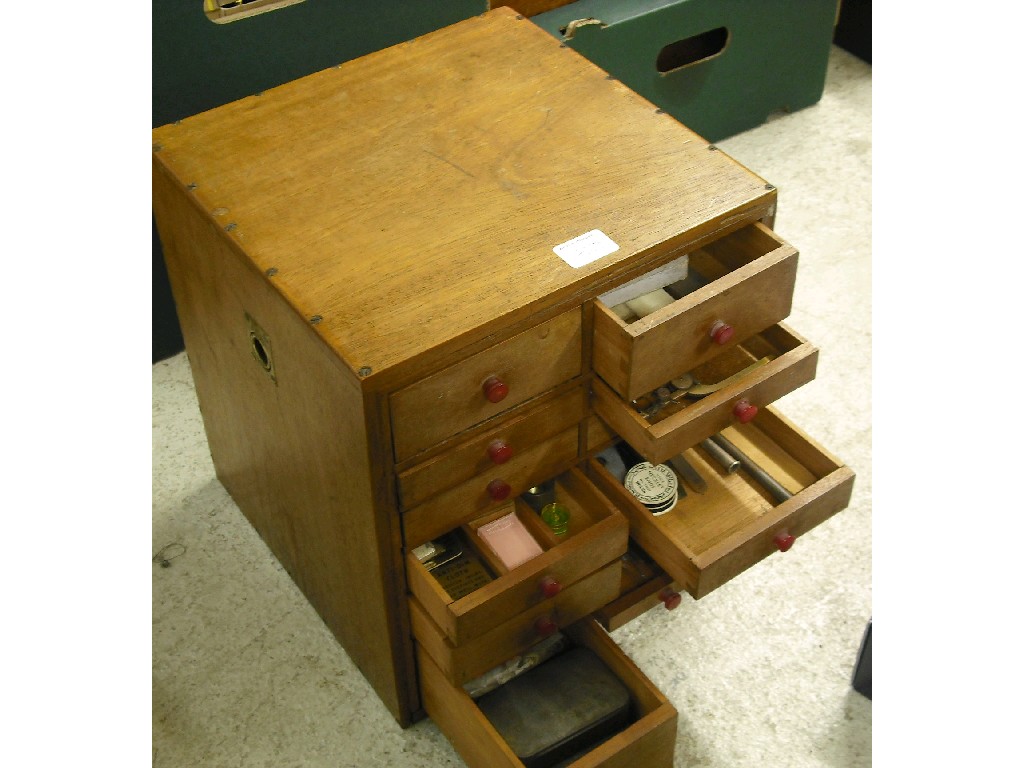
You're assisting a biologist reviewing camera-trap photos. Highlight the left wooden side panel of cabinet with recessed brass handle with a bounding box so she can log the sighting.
[154,159,411,724]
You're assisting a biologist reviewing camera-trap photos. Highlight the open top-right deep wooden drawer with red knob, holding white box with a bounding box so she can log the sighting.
[594,222,798,400]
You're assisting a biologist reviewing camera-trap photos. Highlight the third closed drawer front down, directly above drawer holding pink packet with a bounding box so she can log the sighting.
[401,425,580,547]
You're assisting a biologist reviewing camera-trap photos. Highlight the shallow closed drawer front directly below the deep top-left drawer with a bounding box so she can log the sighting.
[398,387,587,509]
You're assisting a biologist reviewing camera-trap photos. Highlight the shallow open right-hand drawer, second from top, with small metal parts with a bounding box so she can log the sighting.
[593,325,818,464]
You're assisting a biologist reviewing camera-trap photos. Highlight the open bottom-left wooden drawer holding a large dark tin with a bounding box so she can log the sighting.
[418,620,678,768]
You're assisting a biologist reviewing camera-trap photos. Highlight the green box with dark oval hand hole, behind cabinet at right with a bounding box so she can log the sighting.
[532,0,839,141]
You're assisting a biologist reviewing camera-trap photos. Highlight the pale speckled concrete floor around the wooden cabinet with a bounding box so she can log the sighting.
[153,48,871,768]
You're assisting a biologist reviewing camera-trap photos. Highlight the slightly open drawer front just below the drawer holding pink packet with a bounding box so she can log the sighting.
[410,561,622,685]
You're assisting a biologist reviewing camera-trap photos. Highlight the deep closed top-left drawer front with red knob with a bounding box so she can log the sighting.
[390,309,583,462]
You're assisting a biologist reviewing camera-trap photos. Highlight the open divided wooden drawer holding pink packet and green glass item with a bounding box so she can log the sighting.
[406,468,629,660]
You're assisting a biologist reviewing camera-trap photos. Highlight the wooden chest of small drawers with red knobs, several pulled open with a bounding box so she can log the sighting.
[154,8,853,768]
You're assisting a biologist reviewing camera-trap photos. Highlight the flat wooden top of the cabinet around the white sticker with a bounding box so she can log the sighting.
[154,8,773,373]
